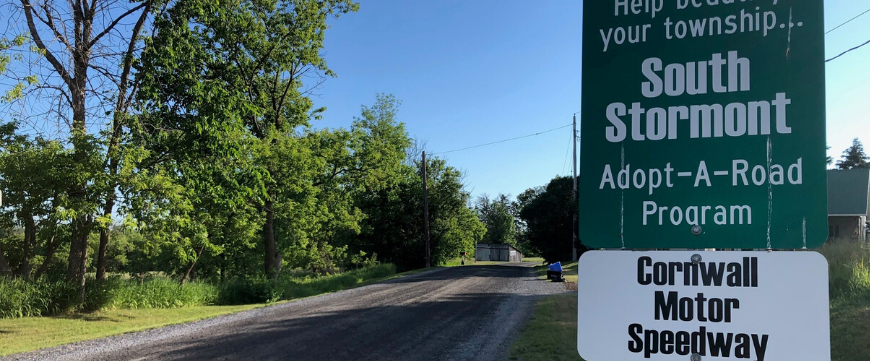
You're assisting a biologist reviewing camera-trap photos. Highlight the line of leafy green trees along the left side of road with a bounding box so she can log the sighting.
[0,0,485,302]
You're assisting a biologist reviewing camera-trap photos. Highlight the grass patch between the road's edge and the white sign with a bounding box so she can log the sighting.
[508,293,583,361]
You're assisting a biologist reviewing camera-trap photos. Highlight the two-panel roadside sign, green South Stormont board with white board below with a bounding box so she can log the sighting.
[577,0,830,361]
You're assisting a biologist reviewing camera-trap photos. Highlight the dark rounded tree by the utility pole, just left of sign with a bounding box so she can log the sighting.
[520,177,585,263]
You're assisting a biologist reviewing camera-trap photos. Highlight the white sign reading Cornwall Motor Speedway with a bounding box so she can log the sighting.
[577,251,831,361]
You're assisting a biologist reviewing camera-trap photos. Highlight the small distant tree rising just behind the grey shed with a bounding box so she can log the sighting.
[474,194,517,247]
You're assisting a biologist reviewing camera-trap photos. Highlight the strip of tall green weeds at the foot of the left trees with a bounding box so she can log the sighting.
[0,264,396,318]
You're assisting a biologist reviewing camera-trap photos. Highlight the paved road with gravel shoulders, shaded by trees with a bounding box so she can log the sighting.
[10,264,564,361]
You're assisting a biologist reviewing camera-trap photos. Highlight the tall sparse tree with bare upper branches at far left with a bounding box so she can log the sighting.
[0,0,154,301]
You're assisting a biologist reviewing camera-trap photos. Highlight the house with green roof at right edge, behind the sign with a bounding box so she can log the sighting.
[828,169,870,240]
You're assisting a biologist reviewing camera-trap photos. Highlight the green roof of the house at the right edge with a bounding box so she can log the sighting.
[828,169,870,216]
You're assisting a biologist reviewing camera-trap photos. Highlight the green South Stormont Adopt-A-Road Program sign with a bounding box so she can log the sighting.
[579,0,828,249]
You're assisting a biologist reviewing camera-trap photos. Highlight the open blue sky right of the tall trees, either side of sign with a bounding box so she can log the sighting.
[315,0,870,200]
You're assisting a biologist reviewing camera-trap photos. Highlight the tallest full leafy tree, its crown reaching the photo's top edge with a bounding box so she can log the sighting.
[140,0,357,276]
